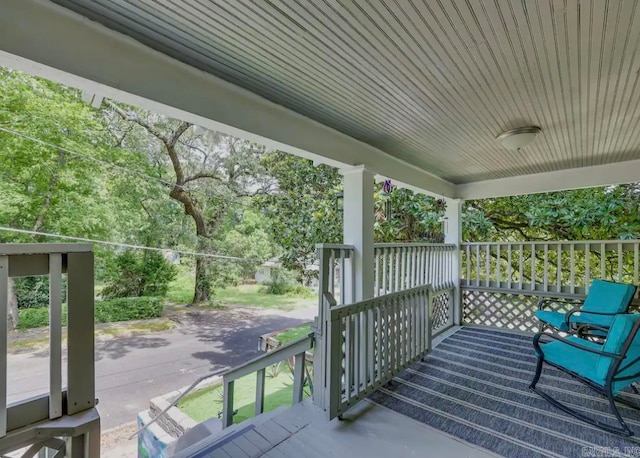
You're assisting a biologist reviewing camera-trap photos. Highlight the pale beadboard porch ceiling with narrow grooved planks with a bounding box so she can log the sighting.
[55,0,640,184]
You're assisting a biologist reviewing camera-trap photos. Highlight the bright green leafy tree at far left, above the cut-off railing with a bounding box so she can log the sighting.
[0,67,119,327]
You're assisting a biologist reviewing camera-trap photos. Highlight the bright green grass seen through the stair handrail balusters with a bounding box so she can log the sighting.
[178,364,309,423]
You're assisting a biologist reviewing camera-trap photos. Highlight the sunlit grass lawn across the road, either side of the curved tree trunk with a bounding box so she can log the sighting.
[167,269,317,310]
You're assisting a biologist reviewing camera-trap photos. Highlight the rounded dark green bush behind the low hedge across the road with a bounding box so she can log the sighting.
[101,250,177,299]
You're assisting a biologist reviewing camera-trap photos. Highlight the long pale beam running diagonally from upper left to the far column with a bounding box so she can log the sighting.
[0,0,455,197]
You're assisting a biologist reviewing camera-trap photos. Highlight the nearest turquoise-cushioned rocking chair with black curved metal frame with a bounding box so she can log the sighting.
[529,313,640,436]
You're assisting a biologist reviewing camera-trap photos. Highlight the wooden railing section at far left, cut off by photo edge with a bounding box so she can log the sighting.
[0,244,100,458]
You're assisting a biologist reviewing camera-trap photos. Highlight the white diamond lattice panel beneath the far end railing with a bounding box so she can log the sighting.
[462,289,576,332]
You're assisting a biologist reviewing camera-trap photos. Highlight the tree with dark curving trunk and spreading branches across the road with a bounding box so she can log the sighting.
[105,101,268,303]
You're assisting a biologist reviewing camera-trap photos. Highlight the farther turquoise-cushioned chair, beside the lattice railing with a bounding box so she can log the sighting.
[534,280,636,332]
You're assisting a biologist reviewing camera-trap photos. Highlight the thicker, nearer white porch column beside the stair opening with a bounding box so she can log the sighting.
[340,165,374,302]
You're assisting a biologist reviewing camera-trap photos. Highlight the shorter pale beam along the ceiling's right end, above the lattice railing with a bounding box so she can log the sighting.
[456,160,640,200]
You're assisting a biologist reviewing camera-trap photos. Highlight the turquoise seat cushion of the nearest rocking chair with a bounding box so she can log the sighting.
[541,337,611,386]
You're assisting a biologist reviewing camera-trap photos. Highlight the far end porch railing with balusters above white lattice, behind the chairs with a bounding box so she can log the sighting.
[461,240,640,331]
